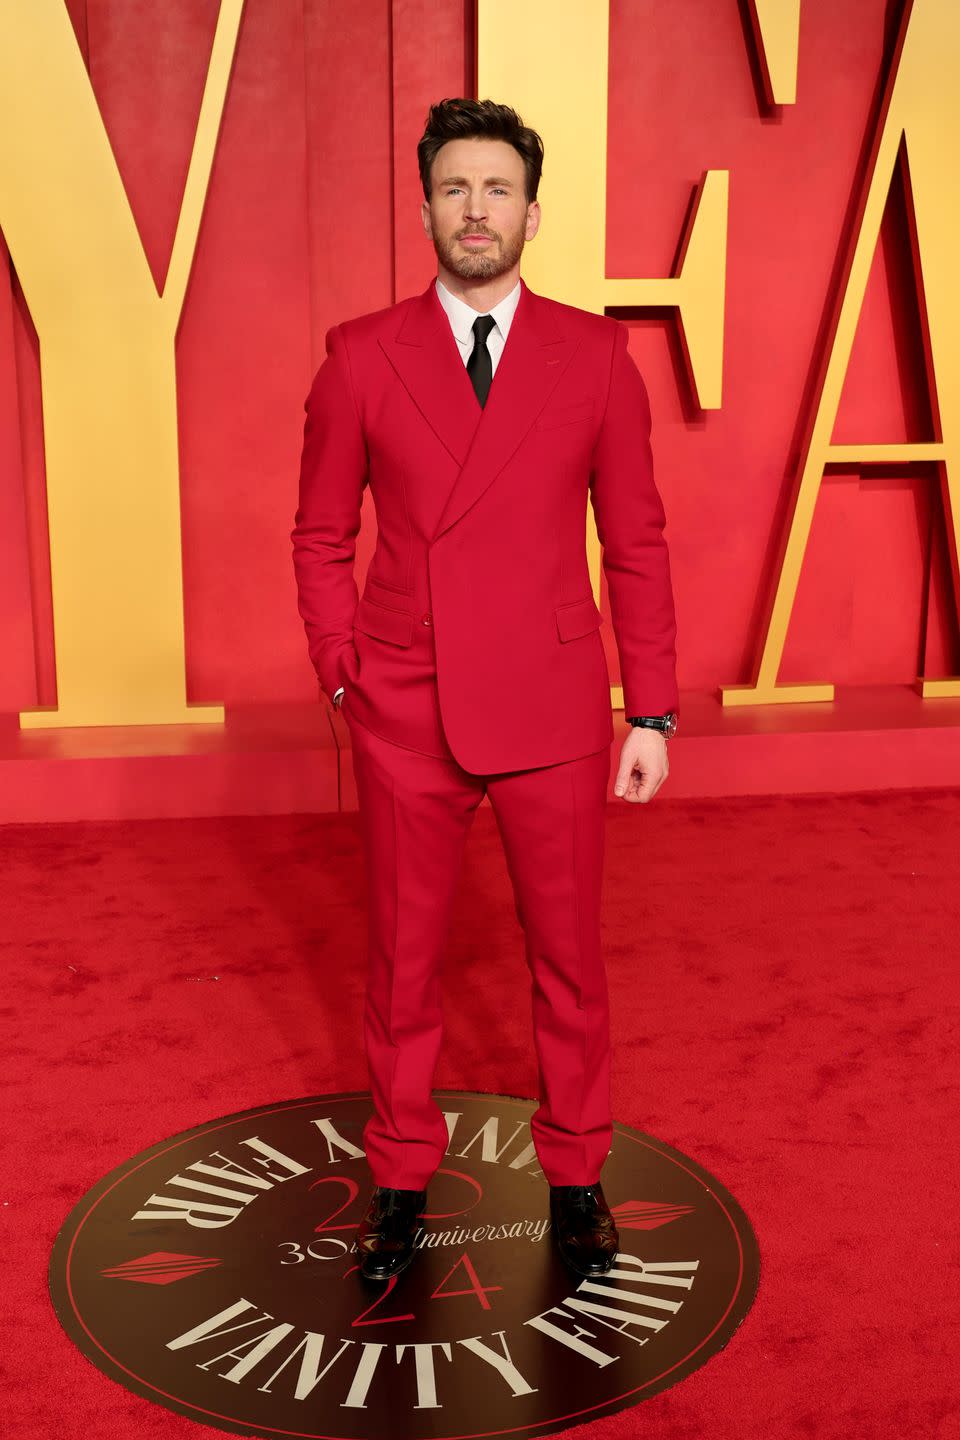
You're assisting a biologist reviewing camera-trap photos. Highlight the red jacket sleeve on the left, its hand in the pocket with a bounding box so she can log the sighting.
[291,325,367,700]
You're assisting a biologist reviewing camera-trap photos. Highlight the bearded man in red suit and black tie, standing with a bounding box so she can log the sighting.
[292,99,678,1279]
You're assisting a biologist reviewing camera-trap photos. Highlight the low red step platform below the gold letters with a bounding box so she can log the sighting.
[0,685,960,824]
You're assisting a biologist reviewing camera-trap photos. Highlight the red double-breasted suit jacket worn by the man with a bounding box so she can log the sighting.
[292,279,678,775]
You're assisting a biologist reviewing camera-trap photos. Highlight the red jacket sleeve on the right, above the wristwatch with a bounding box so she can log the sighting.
[590,320,679,717]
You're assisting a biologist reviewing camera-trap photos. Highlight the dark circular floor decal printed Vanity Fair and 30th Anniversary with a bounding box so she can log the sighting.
[50,1090,759,1440]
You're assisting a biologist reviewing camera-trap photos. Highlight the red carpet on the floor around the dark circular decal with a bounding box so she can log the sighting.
[0,782,960,1440]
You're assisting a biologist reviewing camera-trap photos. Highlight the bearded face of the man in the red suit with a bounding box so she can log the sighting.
[422,140,540,279]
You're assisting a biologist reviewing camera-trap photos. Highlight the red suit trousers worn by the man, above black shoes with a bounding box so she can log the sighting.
[343,690,613,1189]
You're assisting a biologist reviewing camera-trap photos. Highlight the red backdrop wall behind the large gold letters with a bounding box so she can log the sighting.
[0,0,960,710]
